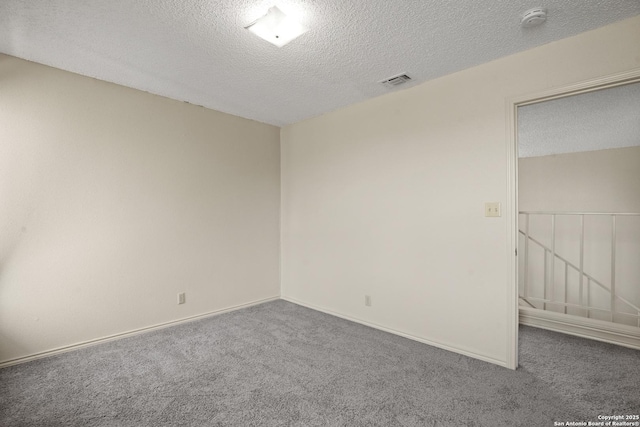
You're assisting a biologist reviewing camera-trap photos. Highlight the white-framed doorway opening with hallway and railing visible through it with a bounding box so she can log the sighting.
[508,70,640,366]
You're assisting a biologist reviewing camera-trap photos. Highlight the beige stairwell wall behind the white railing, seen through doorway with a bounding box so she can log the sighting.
[518,147,640,325]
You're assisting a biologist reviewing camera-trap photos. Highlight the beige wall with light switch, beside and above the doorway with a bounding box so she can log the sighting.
[281,17,640,365]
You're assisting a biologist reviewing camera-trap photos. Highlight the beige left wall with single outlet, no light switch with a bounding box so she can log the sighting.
[0,55,280,361]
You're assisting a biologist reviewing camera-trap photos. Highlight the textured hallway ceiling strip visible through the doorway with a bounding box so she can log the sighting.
[518,83,640,157]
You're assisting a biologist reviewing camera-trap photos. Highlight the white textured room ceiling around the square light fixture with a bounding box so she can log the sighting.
[0,0,640,125]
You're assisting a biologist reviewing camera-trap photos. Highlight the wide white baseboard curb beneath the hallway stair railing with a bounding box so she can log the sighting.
[520,306,640,350]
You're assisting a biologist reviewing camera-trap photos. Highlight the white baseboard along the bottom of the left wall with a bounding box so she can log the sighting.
[0,296,280,369]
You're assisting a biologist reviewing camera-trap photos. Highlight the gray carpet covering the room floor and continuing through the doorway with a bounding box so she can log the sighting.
[0,301,640,427]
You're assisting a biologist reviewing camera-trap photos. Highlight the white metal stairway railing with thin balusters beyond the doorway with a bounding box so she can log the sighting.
[519,211,640,327]
